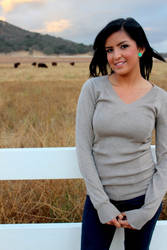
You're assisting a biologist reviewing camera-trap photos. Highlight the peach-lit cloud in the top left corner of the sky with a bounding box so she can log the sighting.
[0,0,44,12]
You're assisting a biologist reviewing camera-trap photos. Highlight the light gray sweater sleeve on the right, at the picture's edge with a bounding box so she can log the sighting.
[126,95,167,229]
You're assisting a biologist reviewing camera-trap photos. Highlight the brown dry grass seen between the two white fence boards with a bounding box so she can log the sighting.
[0,180,85,223]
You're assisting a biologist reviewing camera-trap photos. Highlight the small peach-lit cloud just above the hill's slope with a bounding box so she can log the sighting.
[36,19,71,33]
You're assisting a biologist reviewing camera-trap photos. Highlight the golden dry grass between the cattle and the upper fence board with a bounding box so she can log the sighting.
[0,63,87,147]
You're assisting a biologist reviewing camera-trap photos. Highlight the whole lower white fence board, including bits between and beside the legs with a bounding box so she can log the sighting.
[0,221,167,250]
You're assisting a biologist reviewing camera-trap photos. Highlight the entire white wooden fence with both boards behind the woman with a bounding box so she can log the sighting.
[0,146,167,250]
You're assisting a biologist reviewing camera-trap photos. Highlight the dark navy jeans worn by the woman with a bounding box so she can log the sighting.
[81,195,162,250]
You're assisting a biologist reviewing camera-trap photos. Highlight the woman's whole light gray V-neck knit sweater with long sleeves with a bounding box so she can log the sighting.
[76,76,167,229]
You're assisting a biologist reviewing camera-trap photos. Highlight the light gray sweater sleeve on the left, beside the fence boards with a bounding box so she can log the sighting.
[76,79,120,223]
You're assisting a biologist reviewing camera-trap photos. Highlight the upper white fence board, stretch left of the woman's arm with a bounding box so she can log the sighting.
[0,147,82,180]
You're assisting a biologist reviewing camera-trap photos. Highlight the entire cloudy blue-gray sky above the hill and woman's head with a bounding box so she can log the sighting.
[0,0,167,52]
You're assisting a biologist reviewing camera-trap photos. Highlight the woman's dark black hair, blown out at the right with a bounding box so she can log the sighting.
[89,17,166,80]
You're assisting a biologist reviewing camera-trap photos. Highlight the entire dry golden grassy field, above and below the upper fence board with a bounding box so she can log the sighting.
[0,57,167,223]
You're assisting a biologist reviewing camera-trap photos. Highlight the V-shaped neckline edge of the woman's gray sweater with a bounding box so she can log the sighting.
[106,75,156,106]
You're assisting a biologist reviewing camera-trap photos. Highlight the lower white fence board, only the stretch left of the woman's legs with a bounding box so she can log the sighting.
[0,223,81,250]
